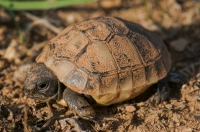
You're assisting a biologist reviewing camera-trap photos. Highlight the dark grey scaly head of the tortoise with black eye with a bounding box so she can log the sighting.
[24,63,59,101]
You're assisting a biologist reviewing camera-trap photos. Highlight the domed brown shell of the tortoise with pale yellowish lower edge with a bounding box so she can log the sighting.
[36,17,171,105]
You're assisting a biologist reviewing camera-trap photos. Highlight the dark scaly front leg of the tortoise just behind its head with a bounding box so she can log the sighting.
[63,88,96,122]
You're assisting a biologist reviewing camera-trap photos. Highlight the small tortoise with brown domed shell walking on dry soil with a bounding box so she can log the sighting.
[24,17,171,120]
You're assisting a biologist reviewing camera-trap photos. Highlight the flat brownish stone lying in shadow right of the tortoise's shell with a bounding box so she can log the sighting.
[170,38,189,52]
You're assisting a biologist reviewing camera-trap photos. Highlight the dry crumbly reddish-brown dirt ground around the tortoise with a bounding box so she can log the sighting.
[0,0,200,132]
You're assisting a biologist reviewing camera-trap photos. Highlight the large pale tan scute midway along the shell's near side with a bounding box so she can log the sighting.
[75,41,117,73]
